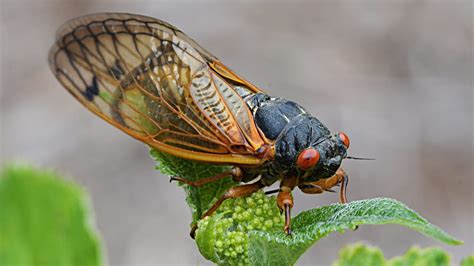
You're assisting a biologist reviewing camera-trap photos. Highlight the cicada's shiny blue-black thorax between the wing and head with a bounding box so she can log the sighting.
[239,93,330,185]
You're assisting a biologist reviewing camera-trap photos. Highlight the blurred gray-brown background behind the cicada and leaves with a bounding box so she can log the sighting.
[0,0,474,265]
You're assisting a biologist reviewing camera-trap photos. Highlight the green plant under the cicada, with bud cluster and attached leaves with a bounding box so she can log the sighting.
[151,150,462,265]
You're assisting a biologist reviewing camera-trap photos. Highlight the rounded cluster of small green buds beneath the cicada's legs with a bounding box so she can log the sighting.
[196,191,284,265]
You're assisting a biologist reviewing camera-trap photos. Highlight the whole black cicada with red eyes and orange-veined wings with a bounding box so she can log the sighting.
[49,13,350,237]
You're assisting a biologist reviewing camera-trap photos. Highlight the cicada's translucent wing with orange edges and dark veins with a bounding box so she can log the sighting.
[49,13,269,165]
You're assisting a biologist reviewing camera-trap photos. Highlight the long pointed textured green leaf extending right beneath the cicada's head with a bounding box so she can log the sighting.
[249,198,462,265]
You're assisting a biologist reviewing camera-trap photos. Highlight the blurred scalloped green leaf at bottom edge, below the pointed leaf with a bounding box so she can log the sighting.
[333,244,451,266]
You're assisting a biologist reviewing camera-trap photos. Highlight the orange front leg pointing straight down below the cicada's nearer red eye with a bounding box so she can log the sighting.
[277,176,298,235]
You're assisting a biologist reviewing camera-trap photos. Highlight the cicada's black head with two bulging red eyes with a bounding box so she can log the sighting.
[275,116,349,182]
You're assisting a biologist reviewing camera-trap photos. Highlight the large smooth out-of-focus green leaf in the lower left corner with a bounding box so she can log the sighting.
[0,164,102,266]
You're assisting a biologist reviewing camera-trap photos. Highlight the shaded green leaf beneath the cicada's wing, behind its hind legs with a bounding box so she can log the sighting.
[150,149,237,223]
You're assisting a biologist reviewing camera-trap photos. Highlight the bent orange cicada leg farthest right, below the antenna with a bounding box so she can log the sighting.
[298,168,349,203]
